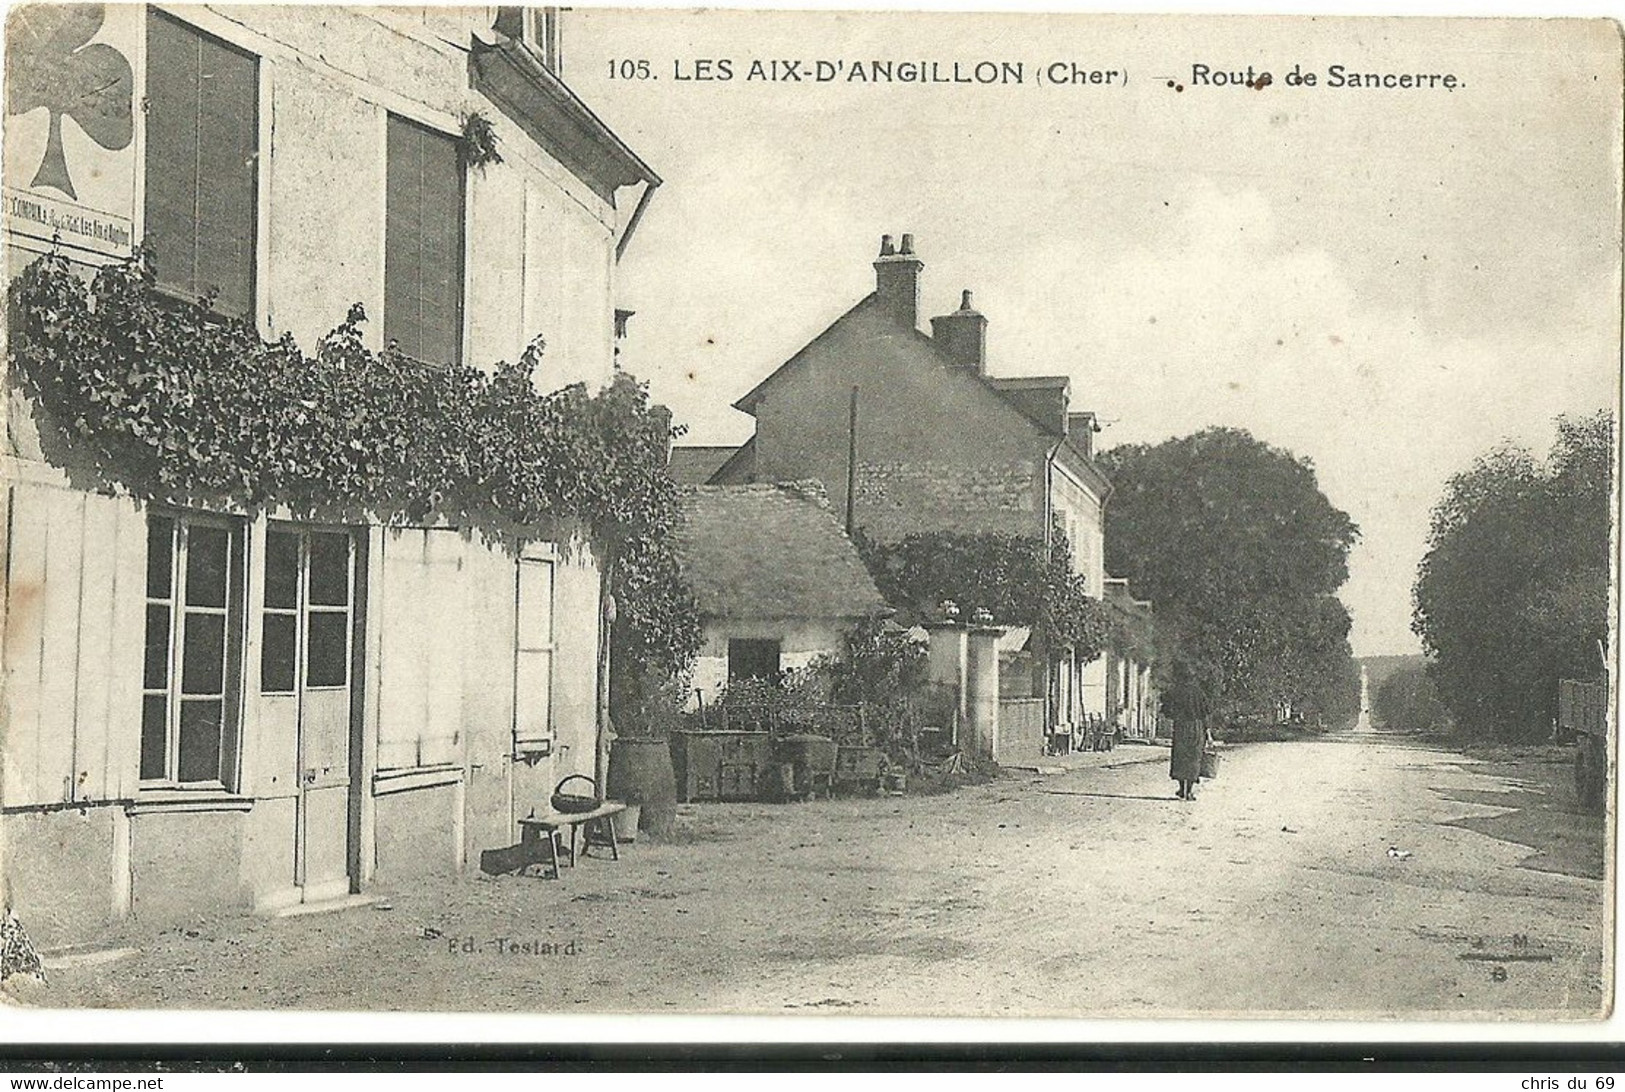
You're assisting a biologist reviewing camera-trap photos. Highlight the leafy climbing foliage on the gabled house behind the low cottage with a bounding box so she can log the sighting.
[853,528,1115,661]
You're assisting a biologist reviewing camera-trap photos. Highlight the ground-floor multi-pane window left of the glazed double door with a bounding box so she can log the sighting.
[141,515,242,788]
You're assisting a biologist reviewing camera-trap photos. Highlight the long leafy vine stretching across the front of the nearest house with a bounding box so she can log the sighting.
[8,254,699,692]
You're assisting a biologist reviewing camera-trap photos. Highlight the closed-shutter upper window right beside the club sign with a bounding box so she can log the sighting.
[143,11,260,315]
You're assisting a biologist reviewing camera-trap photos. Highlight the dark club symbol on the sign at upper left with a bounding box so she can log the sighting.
[5,3,135,200]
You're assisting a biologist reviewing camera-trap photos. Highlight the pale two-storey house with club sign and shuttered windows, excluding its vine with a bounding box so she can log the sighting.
[0,5,660,946]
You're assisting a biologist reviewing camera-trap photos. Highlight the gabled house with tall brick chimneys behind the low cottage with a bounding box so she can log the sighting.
[674,236,1131,760]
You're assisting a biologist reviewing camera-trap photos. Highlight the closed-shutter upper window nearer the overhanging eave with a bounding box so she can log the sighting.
[384,114,463,364]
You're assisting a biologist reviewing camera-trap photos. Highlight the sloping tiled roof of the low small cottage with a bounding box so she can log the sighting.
[678,483,887,619]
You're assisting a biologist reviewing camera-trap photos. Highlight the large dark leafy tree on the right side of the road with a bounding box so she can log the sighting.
[1412,413,1614,739]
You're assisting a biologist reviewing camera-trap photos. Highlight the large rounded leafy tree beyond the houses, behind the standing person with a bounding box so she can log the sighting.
[1100,427,1359,717]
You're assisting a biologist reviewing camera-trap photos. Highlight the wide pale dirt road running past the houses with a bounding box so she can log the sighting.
[31,733,1609,1019]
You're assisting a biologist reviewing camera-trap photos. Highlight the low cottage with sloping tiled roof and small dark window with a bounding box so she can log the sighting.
[678,483,889,700]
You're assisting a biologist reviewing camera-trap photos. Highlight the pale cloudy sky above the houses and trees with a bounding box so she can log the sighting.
[564,10,1620,655]
